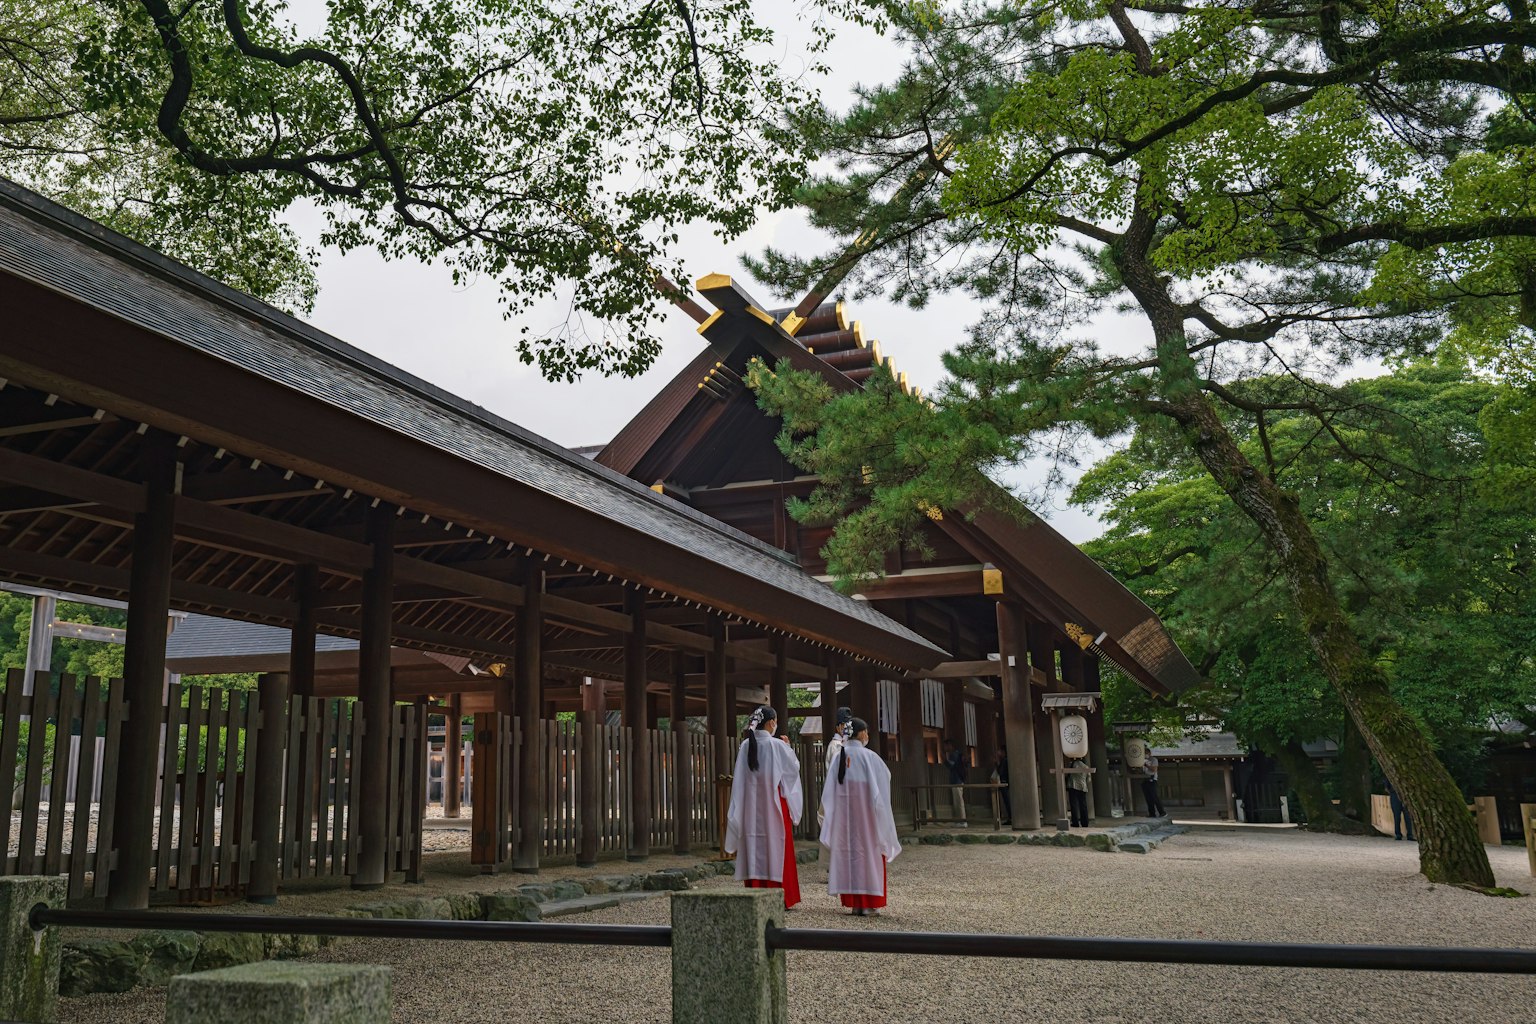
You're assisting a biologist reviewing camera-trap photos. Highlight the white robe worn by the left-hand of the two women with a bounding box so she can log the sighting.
[725,729,805,883]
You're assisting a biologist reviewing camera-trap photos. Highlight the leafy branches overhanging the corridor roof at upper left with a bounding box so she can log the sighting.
[0,0,876,378]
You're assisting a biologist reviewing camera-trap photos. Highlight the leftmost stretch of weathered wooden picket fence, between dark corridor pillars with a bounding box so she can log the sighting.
[0,669,427,900]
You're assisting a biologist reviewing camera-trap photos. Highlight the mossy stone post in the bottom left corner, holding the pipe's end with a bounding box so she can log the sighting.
[0,875,69,1024]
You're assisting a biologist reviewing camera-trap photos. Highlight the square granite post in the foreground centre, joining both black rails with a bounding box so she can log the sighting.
[671,889,790,1024]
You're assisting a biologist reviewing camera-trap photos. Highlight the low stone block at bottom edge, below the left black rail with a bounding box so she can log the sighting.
[166,960,392,1024]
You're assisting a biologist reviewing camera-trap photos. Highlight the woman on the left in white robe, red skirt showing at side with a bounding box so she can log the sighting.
[725,708,805,909]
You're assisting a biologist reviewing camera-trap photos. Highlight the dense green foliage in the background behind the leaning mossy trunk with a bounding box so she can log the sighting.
[1074,364,1536,792]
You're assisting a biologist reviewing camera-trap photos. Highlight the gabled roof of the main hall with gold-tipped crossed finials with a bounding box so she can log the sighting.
[598,275,1200,692]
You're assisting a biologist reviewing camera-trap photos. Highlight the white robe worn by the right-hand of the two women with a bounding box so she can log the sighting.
[822,740,902,897]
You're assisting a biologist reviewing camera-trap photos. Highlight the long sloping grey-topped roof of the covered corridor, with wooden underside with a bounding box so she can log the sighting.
[0,180,943,674]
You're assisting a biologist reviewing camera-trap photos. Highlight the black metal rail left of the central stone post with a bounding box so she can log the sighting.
[31,904,671,947]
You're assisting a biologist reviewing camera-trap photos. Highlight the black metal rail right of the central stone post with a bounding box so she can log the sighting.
[766,924,1536,975]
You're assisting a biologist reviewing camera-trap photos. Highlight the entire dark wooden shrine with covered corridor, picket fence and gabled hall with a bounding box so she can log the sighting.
[0,180,1195,907]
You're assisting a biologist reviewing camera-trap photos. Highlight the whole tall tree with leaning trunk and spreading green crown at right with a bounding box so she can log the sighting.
[743,0,1536,887]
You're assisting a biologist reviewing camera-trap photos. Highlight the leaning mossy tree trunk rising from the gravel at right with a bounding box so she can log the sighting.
[1117,228,1493,889]
